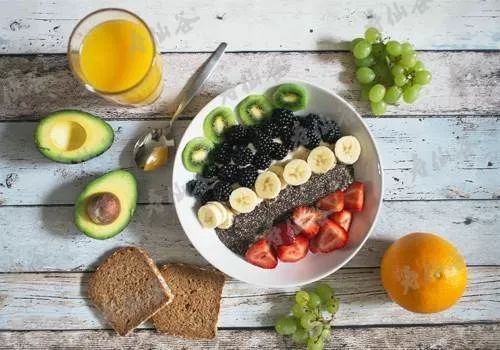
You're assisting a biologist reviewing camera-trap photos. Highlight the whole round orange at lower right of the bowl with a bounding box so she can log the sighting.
[380,232,467,313]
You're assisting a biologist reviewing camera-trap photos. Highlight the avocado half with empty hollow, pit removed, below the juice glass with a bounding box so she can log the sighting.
[34,109,114,163]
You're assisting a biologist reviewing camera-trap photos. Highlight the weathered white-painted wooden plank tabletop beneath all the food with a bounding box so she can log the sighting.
[0,0,500,349]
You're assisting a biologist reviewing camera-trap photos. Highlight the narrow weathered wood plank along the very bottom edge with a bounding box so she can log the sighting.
[0,323,500,350]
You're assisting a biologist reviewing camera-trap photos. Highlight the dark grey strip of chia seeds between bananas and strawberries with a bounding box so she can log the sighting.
[215,164,354,255]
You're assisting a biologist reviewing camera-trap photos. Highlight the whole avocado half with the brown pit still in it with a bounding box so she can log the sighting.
[75,170,137,239]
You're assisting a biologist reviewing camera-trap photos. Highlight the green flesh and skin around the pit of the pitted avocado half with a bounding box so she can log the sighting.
[75,170,137,239]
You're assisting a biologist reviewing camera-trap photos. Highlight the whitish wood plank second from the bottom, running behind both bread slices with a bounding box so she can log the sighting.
[0,267,500,330]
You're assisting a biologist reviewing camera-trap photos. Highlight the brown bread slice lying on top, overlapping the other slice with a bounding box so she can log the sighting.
[88,247,173,335]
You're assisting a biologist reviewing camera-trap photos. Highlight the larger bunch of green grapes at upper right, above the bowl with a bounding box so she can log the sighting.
[351,28,431,116]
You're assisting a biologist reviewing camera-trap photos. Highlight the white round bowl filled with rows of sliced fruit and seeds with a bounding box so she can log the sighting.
[172,80,383,287]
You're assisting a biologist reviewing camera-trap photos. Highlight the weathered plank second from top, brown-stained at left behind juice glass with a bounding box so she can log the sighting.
[0,51,500,120]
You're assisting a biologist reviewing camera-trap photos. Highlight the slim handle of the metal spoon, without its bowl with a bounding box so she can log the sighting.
[169,43,227,128]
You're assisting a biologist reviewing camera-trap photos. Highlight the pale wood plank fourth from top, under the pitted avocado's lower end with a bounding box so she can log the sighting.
[0,200,500,272]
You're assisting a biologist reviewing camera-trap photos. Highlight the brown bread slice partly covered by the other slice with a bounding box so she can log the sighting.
[152,264,225,339]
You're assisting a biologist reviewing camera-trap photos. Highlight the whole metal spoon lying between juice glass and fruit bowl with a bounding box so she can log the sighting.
[134,43,227,171]
